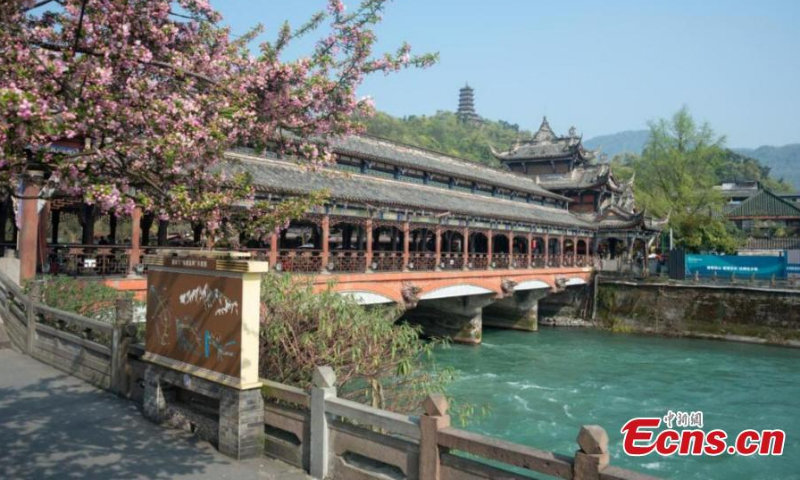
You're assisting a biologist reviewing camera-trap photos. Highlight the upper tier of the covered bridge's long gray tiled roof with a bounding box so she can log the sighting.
[329,135,563,199]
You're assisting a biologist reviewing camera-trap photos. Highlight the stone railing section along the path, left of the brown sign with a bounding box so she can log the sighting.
[0,273,135,393]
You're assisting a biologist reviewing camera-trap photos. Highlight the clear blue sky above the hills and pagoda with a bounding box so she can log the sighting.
[213,0,800,147]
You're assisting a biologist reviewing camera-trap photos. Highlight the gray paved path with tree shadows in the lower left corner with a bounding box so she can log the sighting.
[0,349,309,480]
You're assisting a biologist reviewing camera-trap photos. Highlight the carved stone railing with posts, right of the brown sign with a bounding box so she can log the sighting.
[262,367,654,480]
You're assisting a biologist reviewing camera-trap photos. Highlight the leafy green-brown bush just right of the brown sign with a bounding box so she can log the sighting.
[259,274,462,413]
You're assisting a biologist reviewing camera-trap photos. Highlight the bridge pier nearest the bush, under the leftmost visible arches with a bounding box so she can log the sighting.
[404,294,494,345]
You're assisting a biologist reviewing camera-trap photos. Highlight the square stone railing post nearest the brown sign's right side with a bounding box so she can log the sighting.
[309,365,336,479]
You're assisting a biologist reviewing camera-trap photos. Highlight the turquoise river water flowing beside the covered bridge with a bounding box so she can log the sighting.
[436,328,800,480]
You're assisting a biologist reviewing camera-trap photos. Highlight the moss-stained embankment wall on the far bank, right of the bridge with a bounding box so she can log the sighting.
[595,279,800,345]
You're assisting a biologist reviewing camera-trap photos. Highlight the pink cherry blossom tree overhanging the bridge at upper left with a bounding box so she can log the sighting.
[0,0,436,238]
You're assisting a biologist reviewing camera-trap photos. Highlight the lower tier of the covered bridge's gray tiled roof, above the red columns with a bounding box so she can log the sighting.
[223,152,594,229]
